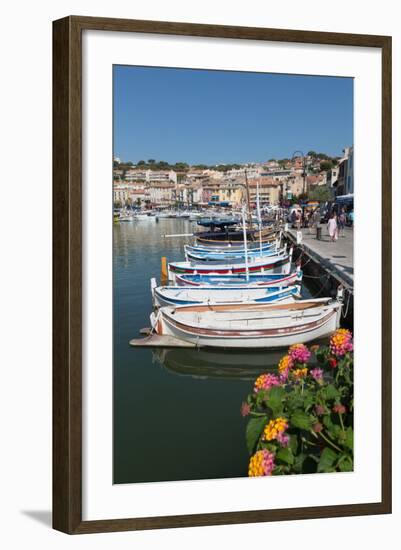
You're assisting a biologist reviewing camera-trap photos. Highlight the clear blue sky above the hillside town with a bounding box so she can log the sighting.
[114,66,353,164]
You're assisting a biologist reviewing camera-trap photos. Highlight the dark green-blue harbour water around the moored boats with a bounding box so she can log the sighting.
[113,218,308,483]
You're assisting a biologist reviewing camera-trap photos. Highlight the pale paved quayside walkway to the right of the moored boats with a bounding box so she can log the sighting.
[288,225,354,287]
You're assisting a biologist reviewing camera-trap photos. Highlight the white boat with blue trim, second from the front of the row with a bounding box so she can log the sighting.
[152,280,300,307]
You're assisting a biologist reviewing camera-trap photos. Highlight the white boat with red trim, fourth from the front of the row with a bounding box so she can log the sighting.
[168,249,292,283]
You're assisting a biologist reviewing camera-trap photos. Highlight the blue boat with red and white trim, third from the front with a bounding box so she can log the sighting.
[175,268,302,288]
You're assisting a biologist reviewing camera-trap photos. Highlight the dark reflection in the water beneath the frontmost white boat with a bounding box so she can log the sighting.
[152,340,327,380]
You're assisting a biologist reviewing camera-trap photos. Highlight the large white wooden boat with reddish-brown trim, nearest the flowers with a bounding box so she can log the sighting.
[151,298,342,348]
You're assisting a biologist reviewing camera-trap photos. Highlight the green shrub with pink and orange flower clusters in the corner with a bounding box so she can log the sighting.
[241,329,354,477]
